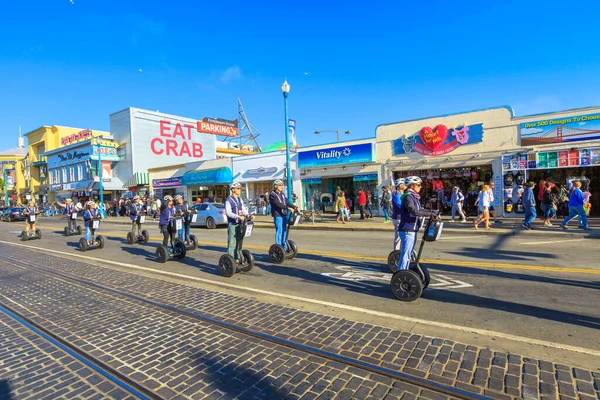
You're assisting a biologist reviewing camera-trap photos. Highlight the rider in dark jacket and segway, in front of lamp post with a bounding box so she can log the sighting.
[269,179,300,264]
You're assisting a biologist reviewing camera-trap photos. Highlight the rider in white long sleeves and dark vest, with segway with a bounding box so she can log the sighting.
[219,182,254,278]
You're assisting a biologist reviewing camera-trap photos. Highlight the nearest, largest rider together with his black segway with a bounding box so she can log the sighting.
[390,176,443,301]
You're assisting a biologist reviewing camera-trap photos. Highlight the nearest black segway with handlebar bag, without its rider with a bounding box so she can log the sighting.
[390,217,444,302]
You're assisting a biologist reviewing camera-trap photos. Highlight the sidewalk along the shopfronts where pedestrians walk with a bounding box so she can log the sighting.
[52,214,600,239]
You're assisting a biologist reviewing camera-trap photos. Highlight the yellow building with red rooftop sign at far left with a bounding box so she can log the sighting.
[22,125,109,202]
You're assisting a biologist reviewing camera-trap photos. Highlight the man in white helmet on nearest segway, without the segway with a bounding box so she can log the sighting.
[398,176,438,270]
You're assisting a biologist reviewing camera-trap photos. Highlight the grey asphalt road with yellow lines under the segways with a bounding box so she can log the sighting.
[0,218,600,369]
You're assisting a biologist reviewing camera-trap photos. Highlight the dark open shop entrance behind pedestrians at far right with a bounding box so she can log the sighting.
[528,167,600,216]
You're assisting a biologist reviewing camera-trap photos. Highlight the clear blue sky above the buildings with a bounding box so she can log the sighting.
[0,0,600,150]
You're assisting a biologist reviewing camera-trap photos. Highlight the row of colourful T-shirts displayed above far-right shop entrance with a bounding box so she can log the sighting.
[502,149,600,171]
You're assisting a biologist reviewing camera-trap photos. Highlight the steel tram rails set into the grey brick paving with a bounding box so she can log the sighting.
[0,255,489,399]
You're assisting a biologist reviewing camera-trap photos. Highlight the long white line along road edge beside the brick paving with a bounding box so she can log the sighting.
[0,240,600,357]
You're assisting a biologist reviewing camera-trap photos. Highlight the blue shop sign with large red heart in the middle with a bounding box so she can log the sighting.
[392,124,483,156]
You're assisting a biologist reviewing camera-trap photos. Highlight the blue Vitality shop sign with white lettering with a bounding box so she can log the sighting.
[298,143,375,168]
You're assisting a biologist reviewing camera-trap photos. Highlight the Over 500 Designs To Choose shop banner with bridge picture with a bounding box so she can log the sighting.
[520,114,600,146]
